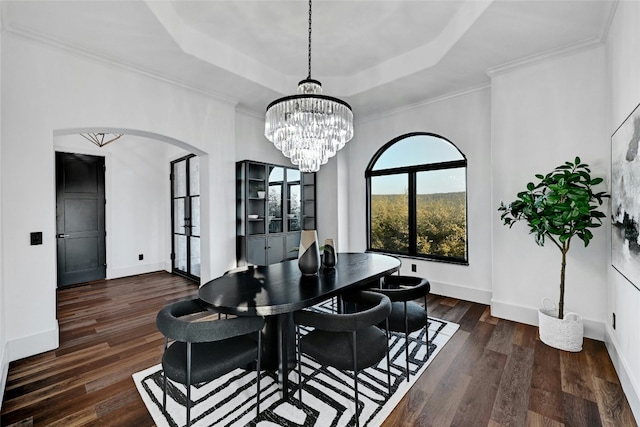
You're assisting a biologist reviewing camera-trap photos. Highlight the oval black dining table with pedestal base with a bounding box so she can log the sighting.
[198,252,401,400]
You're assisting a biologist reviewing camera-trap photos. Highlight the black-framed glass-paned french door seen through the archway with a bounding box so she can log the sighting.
[171,154,200,280]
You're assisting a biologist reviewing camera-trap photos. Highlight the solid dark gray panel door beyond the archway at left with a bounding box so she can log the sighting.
[56,153,107,287]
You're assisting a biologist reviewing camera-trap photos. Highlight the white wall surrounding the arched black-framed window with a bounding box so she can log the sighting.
[342,88,494,304]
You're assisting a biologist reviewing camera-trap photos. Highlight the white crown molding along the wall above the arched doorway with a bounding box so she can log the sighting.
[2,24,239,106]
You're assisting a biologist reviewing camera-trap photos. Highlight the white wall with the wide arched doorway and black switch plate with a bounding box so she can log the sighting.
[0,33,235,360]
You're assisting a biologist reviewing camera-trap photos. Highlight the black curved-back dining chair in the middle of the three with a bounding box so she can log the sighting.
[293,291,391,426]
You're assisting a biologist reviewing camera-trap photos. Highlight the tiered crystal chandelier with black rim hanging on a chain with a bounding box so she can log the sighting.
[264,0,353,172]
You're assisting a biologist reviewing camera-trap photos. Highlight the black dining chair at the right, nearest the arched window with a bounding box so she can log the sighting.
[371,276,431,381]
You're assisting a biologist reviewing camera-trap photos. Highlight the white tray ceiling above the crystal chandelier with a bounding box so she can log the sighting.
[2,0,616,118]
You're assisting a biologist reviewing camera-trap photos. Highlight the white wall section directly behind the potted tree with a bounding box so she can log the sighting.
[491,46,610,340]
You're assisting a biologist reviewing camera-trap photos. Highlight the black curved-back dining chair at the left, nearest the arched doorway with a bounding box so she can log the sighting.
[156,299,264,426]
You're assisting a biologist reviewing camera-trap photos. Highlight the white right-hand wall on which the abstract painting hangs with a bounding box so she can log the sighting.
[605,2,640,420]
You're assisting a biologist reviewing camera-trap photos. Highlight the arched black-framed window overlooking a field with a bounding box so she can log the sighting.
[365,132,468,264]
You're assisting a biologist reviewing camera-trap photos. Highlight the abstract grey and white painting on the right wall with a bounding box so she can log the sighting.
[611,105,640,290]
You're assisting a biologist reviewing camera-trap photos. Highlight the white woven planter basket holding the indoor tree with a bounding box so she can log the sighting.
[538,298,584,352]
